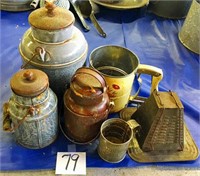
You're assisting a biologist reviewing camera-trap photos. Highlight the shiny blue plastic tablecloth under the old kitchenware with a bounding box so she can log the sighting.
[0,3,200,170]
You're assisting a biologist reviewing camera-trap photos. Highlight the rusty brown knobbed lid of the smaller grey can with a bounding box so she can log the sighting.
[10,69,49,97]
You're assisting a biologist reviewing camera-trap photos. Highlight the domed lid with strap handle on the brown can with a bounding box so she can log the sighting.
[70,67,106,97]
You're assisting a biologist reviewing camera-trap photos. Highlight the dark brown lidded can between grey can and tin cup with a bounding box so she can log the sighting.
[63,67,112,144]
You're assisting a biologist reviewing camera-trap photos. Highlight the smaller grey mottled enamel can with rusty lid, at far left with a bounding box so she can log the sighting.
[3,69,58,149]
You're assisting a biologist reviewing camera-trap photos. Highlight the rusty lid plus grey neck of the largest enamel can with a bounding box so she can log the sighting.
[28,3,75,43]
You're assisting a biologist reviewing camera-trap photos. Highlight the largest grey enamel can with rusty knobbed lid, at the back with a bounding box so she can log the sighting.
[19,2,88,97]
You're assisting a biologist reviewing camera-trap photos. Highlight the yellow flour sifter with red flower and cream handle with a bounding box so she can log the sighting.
[89,45,163,113]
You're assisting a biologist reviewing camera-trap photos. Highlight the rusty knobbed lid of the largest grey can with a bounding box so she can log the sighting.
[28,1,75,30]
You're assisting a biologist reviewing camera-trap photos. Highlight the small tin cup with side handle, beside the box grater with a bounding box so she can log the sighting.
[98,118,140,163]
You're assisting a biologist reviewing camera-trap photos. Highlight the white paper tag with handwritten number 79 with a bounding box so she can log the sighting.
[56,152,86,175]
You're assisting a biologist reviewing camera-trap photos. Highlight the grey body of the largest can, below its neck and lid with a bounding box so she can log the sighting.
[19,27,88,98]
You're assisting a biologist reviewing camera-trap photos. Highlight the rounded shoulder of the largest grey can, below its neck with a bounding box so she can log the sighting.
[19,26,88,66]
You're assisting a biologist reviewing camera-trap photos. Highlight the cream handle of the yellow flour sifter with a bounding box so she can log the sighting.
[137,64,163,93]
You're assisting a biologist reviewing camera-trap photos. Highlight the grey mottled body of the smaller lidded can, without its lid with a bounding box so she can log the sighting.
[8,88,58,149]
